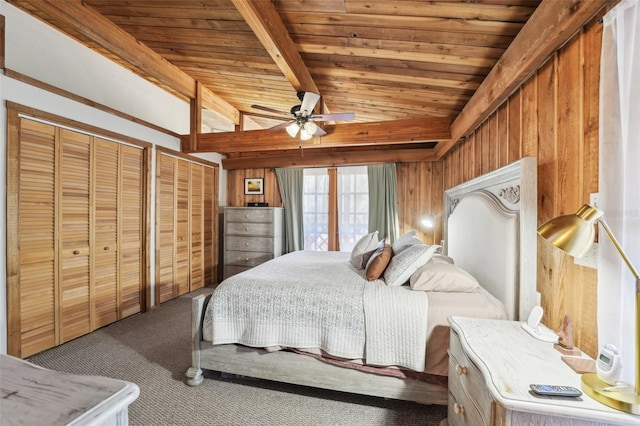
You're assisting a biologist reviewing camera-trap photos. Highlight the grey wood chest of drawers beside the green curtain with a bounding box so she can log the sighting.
[223,207,284,279]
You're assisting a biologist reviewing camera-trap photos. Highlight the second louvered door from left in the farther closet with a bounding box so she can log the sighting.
[174,161,191,297]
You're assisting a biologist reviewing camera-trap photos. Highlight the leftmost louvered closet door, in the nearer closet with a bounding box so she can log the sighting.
[17,119,56,357]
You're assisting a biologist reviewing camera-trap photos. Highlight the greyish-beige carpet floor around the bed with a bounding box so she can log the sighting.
[29,289,447,426]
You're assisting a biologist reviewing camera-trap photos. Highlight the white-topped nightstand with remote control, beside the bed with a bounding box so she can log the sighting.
[448,317,640,426]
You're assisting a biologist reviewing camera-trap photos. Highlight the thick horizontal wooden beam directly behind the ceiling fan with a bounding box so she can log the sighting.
[181,118,451,153]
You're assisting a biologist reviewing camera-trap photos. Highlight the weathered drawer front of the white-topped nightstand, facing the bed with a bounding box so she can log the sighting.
[448,330,493,425]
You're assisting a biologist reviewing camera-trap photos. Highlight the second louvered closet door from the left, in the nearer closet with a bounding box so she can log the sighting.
[59,129,91,343]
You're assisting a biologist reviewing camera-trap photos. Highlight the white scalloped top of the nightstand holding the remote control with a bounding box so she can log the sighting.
[449,317,640,425]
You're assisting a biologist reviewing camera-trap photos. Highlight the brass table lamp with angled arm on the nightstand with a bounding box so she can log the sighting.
[538,204,640,415]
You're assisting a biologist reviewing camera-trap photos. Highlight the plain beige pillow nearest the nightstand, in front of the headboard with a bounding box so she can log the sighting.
[409,261,480,293]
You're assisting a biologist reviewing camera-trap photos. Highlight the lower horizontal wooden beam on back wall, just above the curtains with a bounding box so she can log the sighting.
[222,148,436,170]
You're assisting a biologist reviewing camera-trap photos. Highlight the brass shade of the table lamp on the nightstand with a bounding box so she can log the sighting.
[538,204,602,257]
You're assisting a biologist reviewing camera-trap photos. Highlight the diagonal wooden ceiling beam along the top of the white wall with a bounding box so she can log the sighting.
[25,0,240,124]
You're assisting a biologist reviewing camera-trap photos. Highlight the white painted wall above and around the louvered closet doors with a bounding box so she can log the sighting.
[0,0,226,354]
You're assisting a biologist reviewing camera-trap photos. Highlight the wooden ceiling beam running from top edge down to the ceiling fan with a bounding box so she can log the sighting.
[232,0,320,93]
